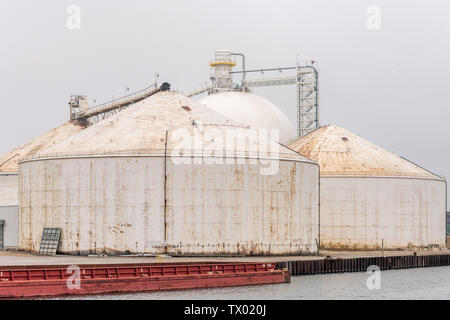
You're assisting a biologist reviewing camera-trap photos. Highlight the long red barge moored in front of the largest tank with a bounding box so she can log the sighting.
[0,263,290,299]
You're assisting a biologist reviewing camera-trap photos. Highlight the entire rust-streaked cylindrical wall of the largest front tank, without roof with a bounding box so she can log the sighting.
[19,156,319,255]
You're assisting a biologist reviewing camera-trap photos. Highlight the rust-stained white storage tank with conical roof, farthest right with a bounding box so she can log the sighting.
[289,126,446,249]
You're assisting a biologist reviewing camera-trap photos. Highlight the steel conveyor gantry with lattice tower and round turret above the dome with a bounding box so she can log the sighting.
[187,50,319,137]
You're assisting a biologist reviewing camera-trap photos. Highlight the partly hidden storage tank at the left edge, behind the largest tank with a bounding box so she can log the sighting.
[0,121,85,248]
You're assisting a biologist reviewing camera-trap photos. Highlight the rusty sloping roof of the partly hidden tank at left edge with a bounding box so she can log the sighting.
[0,121,86,173]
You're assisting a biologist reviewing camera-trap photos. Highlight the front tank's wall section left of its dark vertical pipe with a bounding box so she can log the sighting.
[19,158,164,254]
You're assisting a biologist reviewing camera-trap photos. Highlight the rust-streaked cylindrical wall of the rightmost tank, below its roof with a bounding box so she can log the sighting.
[320,176,446,249]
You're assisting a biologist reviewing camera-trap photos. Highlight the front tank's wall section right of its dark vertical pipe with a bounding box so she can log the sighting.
[168,161,319,255]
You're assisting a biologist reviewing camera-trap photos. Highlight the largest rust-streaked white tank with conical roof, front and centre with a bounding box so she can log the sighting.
[19,91,319,255]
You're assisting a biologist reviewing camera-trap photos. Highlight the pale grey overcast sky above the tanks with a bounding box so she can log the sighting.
[0,0,450,206]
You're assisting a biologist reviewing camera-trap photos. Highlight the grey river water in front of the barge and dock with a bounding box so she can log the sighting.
[59,267,450,300]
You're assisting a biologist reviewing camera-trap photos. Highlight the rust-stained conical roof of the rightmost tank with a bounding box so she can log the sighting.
[288,126,442,179]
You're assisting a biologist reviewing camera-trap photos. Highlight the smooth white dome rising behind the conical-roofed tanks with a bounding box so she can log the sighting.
[199,91,297,144]
